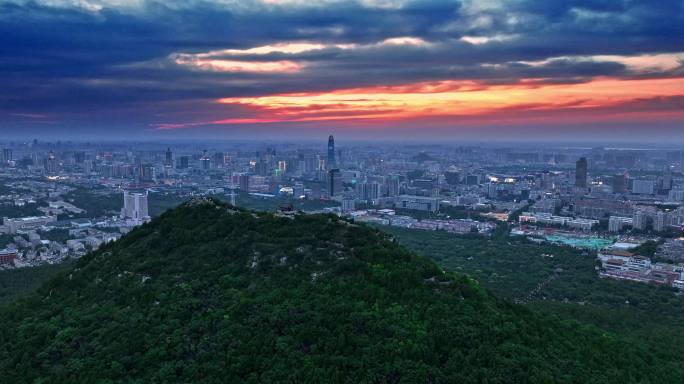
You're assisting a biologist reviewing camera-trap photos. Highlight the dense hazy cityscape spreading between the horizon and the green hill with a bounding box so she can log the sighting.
[0,135,684,289]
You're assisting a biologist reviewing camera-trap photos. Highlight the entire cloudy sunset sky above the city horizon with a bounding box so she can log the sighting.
[0,0,684,141]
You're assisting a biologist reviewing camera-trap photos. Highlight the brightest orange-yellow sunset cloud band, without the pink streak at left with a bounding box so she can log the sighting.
[218,78,684,121]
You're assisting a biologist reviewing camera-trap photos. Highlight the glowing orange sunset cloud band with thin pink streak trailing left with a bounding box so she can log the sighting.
[157,78,684,129]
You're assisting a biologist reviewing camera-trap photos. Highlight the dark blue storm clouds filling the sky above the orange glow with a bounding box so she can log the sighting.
[0,0,684,130]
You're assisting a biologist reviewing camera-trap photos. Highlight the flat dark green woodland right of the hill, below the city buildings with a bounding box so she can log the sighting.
[382,227,684,376]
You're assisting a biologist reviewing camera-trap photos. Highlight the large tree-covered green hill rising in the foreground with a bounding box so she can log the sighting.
[0,200,684,383]
